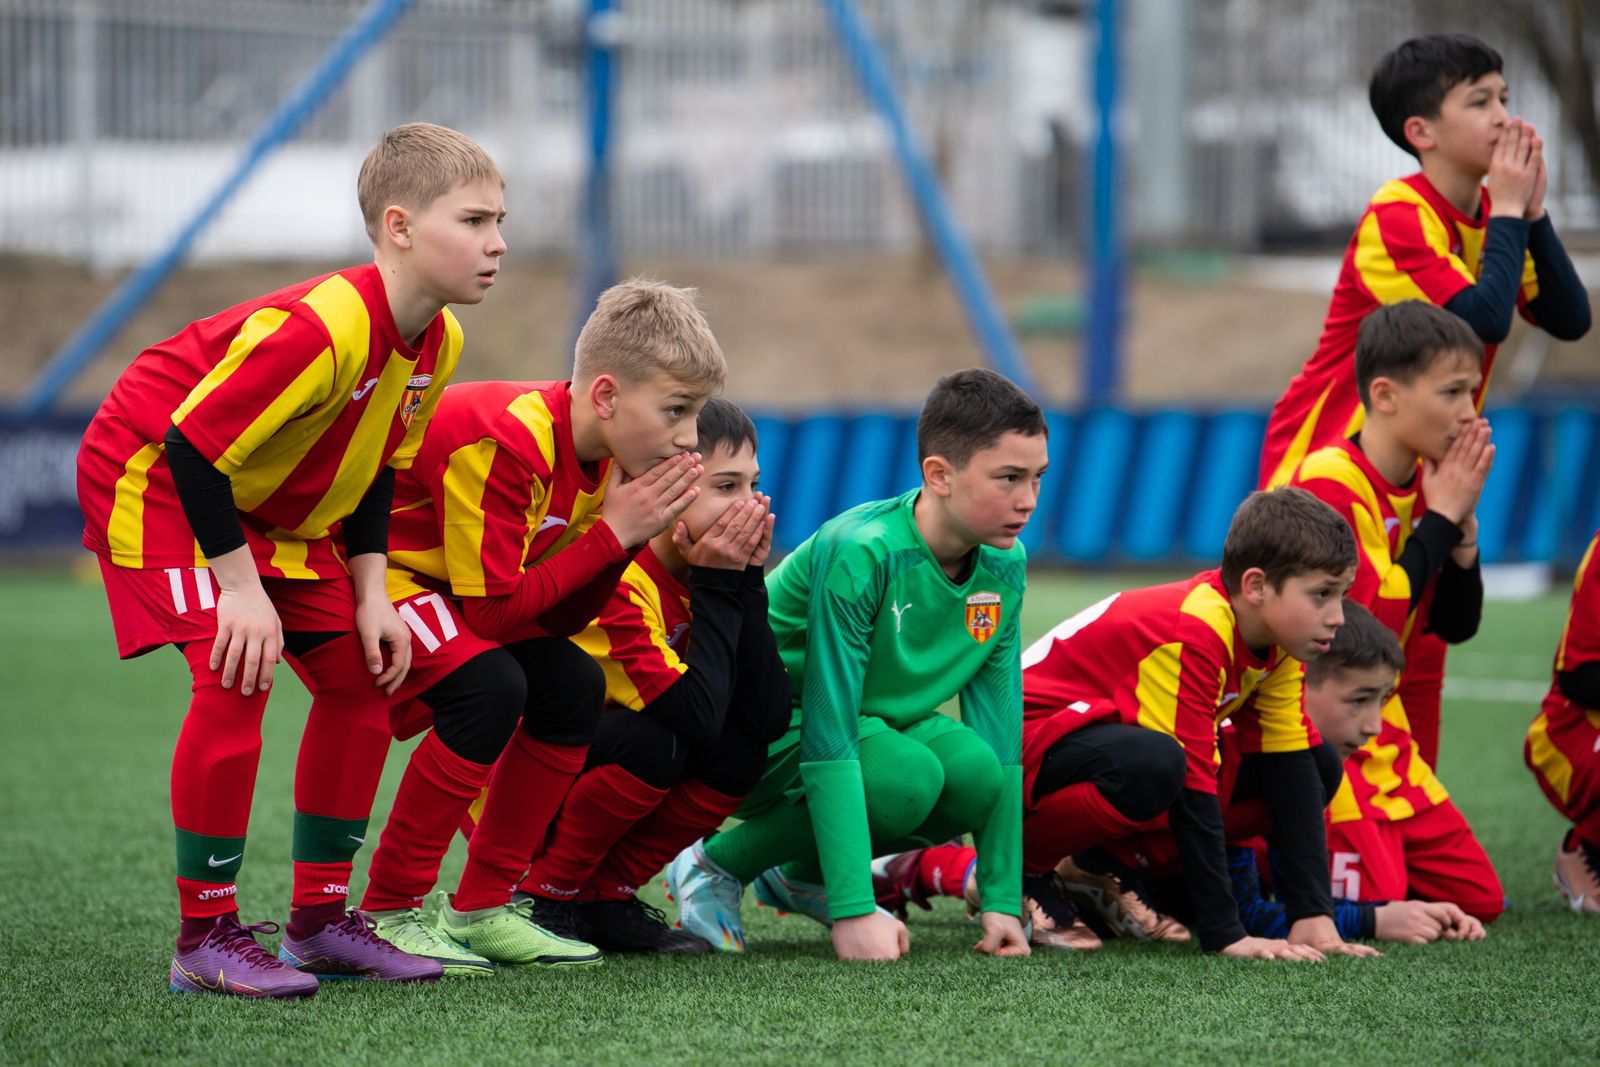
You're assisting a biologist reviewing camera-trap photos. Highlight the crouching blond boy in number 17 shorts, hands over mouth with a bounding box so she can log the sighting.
[362,280,726,974]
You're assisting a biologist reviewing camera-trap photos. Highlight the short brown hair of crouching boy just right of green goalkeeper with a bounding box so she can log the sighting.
[1222,486,1355,592]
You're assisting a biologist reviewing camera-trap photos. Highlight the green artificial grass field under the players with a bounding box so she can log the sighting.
[0,573,1600,1067]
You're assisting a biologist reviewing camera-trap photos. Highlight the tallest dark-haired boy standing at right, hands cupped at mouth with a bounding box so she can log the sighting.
[1261,34,1590,765]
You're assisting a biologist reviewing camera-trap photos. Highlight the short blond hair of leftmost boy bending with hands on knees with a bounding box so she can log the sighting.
[355,122,506,242]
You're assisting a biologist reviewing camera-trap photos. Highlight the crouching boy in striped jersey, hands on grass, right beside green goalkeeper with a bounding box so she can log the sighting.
[1022,490,1371,960]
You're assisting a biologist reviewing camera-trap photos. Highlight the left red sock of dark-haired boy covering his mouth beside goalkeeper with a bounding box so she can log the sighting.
[518,763,667,901]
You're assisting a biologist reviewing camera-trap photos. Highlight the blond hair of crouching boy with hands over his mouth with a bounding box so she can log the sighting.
[573,278,728,392]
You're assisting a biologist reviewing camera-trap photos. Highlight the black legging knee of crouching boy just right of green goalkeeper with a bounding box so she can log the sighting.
[1034,723,1184,822]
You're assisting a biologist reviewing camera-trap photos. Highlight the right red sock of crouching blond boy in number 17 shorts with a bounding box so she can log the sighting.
[451,729,589,912]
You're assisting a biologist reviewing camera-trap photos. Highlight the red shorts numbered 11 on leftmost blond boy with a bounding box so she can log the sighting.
[96,557,355,659]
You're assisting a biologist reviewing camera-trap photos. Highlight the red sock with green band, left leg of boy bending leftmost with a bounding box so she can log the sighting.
[171,641,267,927]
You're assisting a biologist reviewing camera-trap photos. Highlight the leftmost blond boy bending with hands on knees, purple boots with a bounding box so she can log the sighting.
[78,123,506,997]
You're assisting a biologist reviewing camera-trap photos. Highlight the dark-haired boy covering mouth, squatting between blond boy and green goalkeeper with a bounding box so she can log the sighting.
[483,397,790,953]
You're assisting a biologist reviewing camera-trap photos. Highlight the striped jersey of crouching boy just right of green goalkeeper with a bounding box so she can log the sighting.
[1022,571,1322,793]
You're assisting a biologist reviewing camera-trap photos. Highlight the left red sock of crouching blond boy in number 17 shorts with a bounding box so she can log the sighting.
[362,731,494,912]
